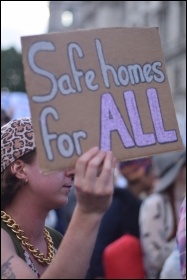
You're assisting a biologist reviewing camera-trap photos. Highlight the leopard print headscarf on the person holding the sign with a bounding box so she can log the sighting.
[1,117,36,173]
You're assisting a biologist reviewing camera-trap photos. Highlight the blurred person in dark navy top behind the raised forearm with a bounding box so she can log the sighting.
[86,158,152,279]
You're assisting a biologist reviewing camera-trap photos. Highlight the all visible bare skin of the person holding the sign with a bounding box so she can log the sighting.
[1,147,116,279]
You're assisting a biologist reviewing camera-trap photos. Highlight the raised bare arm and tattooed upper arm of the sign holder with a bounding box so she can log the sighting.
[1,148,115,279]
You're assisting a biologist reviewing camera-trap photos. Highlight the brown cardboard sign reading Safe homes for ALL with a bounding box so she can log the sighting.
[22,28,183,173]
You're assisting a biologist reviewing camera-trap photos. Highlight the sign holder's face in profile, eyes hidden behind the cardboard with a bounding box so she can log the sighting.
[26,156,75,209]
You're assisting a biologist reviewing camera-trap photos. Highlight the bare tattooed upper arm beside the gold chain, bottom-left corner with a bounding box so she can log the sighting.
[1,229,36,279]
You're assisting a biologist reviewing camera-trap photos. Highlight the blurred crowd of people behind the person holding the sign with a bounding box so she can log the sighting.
[1,93,186,279]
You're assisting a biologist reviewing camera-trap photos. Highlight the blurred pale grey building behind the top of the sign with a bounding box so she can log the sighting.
[48,1,186,143]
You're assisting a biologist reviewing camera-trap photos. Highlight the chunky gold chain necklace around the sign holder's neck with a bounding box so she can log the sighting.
[1,211,54,265]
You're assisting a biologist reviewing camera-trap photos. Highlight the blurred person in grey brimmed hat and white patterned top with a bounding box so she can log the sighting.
[139,151,186,279]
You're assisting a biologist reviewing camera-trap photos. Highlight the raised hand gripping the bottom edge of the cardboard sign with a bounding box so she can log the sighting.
[74,147,116,214]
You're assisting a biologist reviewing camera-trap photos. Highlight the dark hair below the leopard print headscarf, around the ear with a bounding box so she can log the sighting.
[1,149,36,210]
